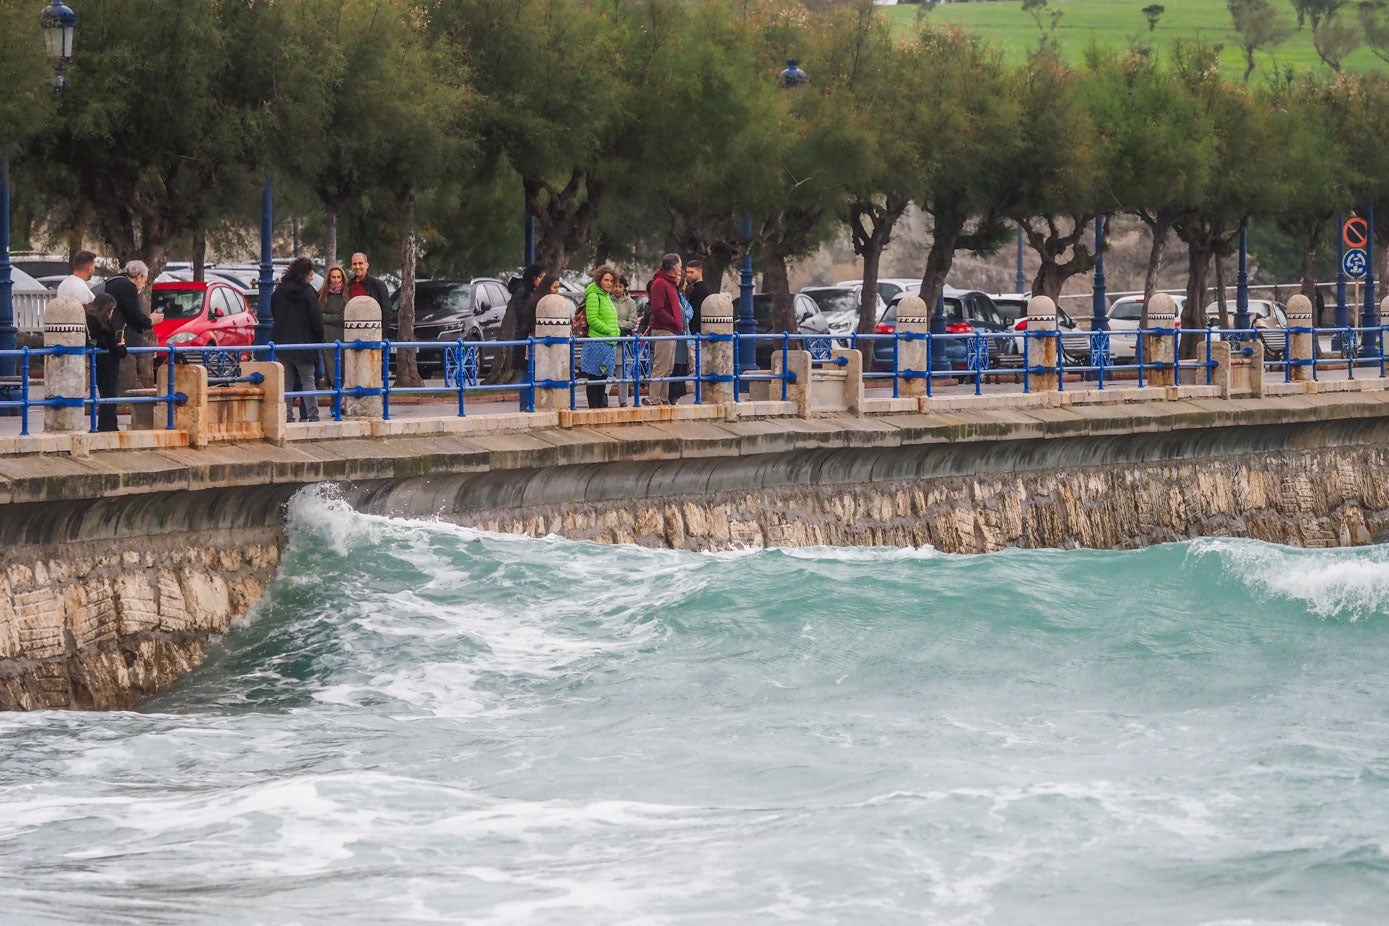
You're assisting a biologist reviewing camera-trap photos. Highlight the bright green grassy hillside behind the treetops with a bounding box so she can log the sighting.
[888,0,1389,82]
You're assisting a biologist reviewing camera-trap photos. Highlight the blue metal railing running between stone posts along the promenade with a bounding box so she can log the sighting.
[0,325,1389,435]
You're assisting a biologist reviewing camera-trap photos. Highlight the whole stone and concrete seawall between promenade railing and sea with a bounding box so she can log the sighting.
[0,393,1389,709]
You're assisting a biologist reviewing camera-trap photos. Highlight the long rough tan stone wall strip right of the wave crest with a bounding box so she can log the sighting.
[443,446,1389,553]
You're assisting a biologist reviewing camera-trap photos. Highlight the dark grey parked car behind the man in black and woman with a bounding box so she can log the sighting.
[385,276,511,379]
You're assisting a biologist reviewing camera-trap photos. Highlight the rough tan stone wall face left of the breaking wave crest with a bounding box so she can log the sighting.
[0,528,282,711]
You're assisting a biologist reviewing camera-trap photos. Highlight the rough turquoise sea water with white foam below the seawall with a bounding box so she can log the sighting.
[0,491,1389,926]
